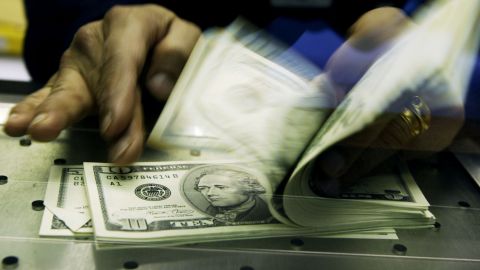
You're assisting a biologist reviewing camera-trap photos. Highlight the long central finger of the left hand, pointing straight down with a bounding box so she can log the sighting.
[96,5,174,140]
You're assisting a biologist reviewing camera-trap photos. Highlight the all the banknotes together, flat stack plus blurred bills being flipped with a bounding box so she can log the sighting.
[40,0,480,245]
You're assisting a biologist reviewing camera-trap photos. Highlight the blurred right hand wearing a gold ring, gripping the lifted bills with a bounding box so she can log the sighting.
[312,8,464,195]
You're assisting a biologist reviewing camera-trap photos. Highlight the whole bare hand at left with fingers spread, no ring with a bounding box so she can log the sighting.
[4,5,201,163]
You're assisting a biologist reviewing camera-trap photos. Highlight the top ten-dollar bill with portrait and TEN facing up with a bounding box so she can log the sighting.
[84,161,404,245]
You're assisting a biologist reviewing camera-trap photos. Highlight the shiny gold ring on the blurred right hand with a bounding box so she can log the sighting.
[400,96,431,137]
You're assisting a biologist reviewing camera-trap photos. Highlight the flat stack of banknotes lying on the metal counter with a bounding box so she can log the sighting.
[40,161,433,245]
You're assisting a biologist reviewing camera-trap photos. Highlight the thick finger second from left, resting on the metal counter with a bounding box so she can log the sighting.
[27,68,94,141]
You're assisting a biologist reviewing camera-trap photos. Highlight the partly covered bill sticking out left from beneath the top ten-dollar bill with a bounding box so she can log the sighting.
[39,165,93,237]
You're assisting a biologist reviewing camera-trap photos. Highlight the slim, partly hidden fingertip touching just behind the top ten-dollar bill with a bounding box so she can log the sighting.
[109,89,145,164]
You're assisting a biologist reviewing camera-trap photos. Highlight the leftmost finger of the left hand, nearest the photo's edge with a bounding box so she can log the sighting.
[4,74,56,136]
